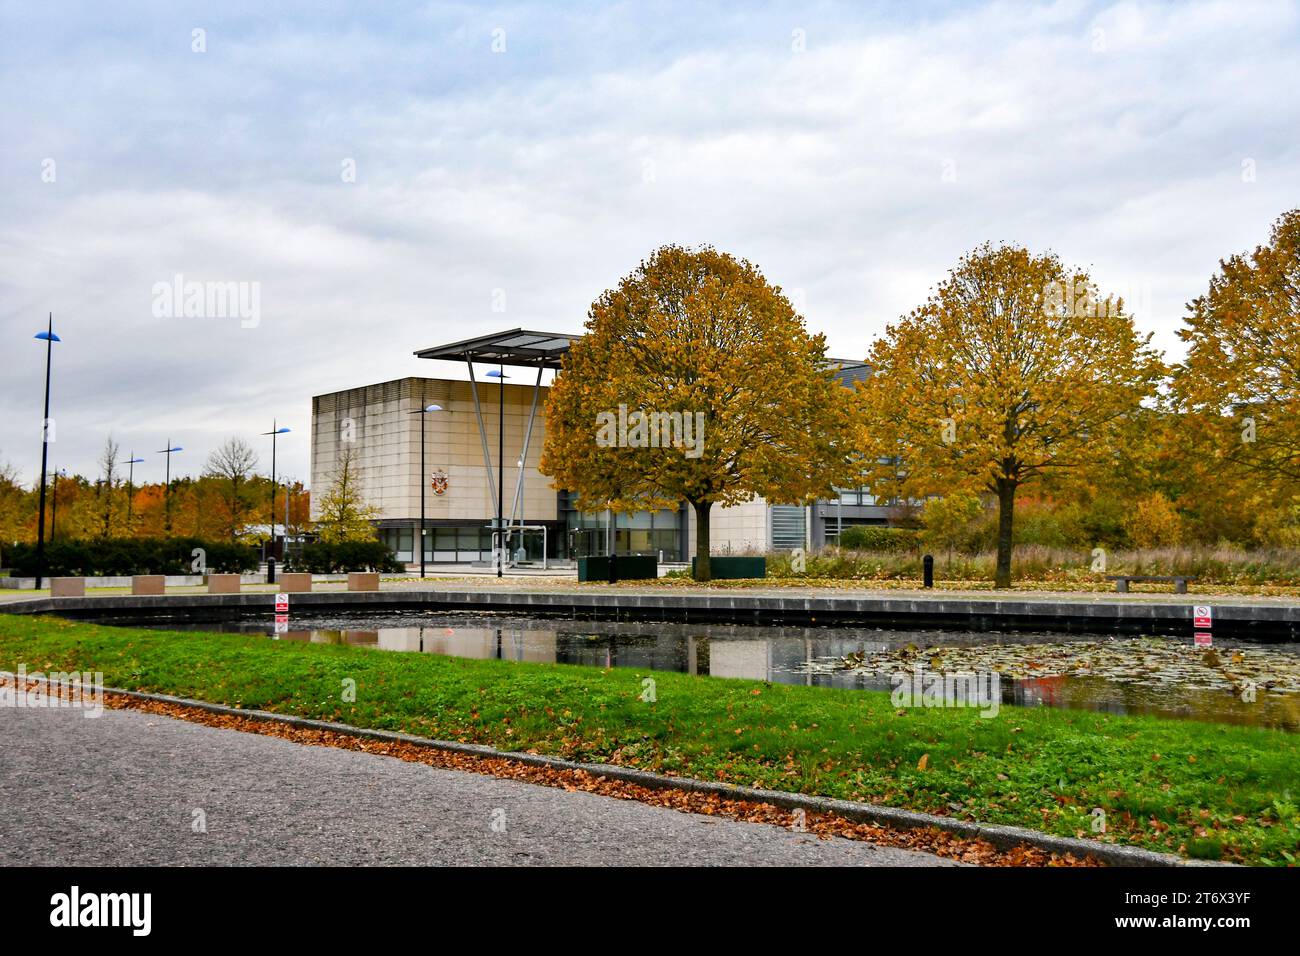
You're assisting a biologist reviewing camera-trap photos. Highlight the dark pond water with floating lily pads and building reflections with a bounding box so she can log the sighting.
[113,611,1300,731]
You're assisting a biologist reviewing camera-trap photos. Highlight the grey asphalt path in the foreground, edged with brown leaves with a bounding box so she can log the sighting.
[0,708,953,866]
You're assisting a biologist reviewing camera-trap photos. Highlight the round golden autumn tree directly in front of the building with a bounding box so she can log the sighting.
[541,246,849,581]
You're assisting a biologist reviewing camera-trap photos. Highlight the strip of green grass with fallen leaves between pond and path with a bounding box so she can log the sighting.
[0,615,1300,865]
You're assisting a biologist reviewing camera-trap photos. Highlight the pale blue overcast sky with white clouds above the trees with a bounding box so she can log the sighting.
[0,0,1300,481]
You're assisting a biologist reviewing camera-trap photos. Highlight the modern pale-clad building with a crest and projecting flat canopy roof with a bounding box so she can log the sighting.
[312,329,893,563]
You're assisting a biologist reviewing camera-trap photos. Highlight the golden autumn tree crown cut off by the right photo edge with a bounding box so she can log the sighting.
[1174,209,1300,497]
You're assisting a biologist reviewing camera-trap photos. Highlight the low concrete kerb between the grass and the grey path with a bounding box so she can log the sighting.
[22,679,1234,868]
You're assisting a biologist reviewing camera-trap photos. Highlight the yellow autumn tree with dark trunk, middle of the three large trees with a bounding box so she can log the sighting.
[859,243,1164,588]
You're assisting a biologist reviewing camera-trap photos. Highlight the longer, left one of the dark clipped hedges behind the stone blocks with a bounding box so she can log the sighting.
[9,537,259,578]
